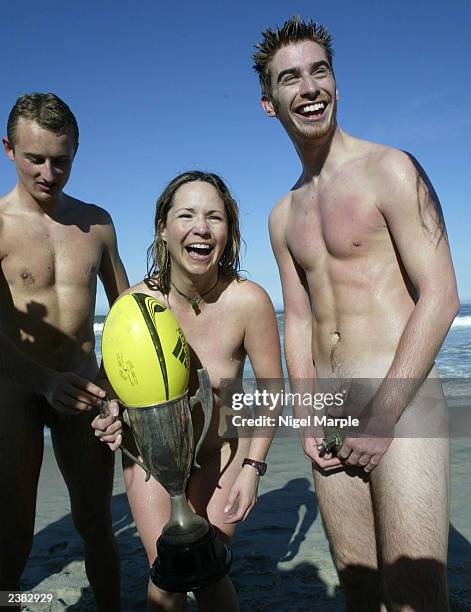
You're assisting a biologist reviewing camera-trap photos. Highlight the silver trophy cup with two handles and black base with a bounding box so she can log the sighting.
[101,369,232,593]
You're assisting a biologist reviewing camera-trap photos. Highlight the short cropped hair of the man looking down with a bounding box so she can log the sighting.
[7,92,79,150]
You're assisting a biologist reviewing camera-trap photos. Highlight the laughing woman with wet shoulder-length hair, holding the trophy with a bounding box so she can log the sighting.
[94,171,282,612]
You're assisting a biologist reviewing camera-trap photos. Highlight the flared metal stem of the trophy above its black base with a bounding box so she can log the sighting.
[162,493,209,545]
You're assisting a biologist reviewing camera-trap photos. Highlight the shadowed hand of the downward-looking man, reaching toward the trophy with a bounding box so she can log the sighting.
[43,372,106,415]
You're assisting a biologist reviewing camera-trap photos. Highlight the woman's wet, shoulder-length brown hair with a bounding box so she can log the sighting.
[146,170,241,295]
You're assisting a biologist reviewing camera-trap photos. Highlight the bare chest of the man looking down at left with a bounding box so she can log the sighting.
[1,216,102,290]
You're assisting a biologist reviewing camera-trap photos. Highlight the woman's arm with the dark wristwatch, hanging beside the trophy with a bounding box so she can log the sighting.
[224,281,283,523]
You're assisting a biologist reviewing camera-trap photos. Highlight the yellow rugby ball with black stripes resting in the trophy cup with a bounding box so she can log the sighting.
[101,293,190,406]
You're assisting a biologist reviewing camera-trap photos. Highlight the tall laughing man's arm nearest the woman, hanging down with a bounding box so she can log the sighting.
[269,200,341,470]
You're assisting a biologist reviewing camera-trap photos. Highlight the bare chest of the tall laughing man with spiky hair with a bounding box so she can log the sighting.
[286,188,386,271]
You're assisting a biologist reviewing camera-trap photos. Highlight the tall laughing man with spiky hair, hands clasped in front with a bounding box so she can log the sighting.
[254,17,459,612]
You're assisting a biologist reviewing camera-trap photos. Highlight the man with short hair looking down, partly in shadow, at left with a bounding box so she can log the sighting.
[0,93,128,612]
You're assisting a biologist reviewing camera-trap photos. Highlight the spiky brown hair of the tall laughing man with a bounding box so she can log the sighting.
[252,15,334,98]
